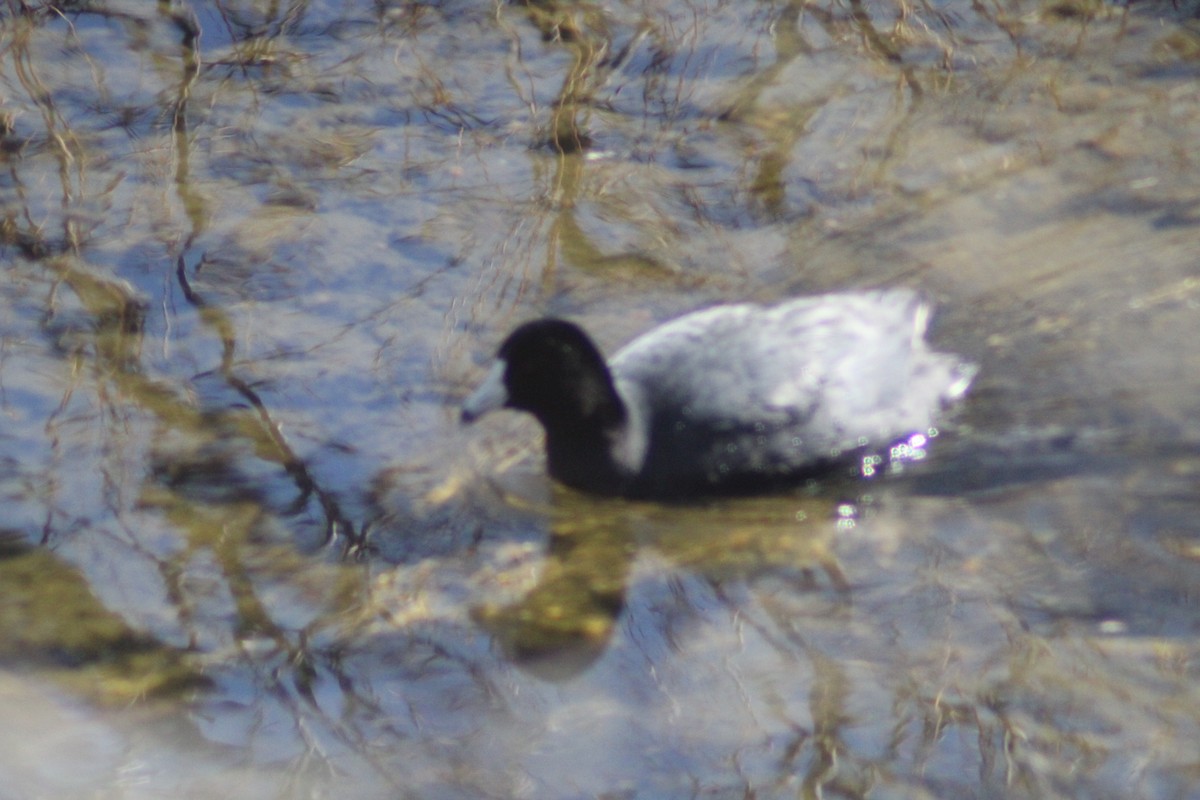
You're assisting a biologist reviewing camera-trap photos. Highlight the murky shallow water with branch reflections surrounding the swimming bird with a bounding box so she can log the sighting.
[0,2,1200,798]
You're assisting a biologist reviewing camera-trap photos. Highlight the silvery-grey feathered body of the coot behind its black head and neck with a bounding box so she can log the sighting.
[611,290,973,493]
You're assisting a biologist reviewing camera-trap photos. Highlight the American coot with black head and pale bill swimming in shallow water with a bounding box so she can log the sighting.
[462,290,974,498]
